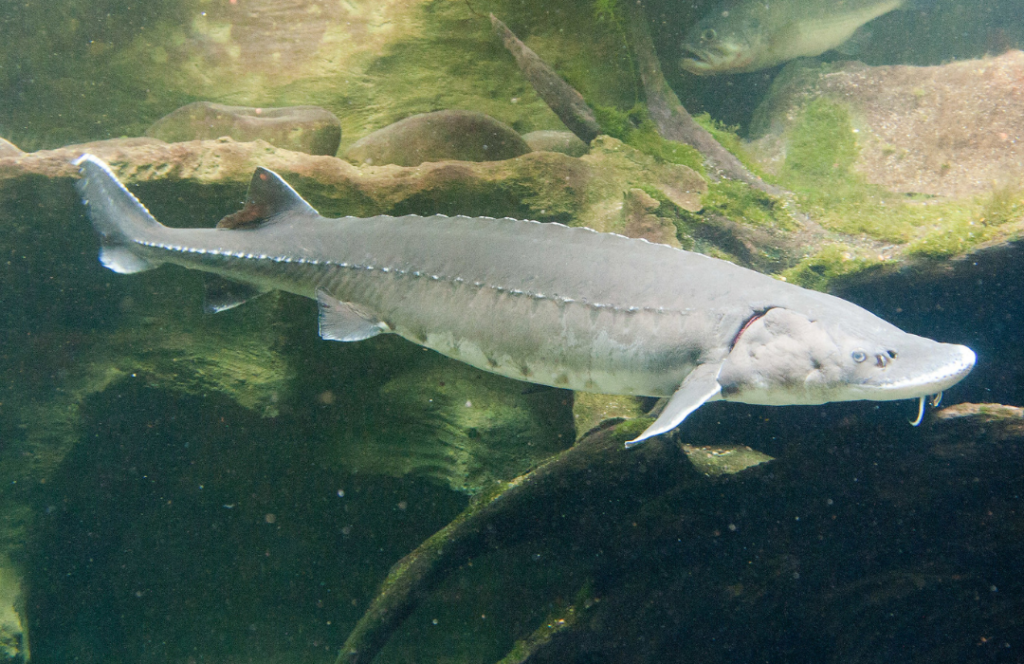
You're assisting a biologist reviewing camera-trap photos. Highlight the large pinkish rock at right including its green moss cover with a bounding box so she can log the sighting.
[752,56,1024,289]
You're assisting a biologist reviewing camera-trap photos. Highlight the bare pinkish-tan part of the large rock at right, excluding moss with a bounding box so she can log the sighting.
[751,50,1024,197]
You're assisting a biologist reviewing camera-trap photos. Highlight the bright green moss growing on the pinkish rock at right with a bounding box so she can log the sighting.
[737,97,1024,290]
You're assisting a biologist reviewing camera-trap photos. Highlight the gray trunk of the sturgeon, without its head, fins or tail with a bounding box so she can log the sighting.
[108,203,770,397]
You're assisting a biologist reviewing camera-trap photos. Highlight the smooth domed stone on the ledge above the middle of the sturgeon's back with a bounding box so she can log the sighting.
[345,111,530,166]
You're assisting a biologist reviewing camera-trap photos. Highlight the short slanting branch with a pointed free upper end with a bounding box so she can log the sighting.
[490,14,601,146]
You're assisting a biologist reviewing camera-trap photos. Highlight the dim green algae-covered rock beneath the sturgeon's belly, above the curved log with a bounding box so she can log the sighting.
[337,360,575,493]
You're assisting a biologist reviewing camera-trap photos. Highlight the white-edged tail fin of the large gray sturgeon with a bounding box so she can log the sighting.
[74,154,163,275]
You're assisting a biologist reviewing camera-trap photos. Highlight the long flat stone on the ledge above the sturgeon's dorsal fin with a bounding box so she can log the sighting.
[145,101,341,156]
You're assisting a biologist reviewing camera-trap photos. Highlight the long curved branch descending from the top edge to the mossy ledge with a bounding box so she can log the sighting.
[627,3,785,196]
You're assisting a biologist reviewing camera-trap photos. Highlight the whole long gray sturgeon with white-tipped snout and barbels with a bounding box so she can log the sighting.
[75,155,975,444]
